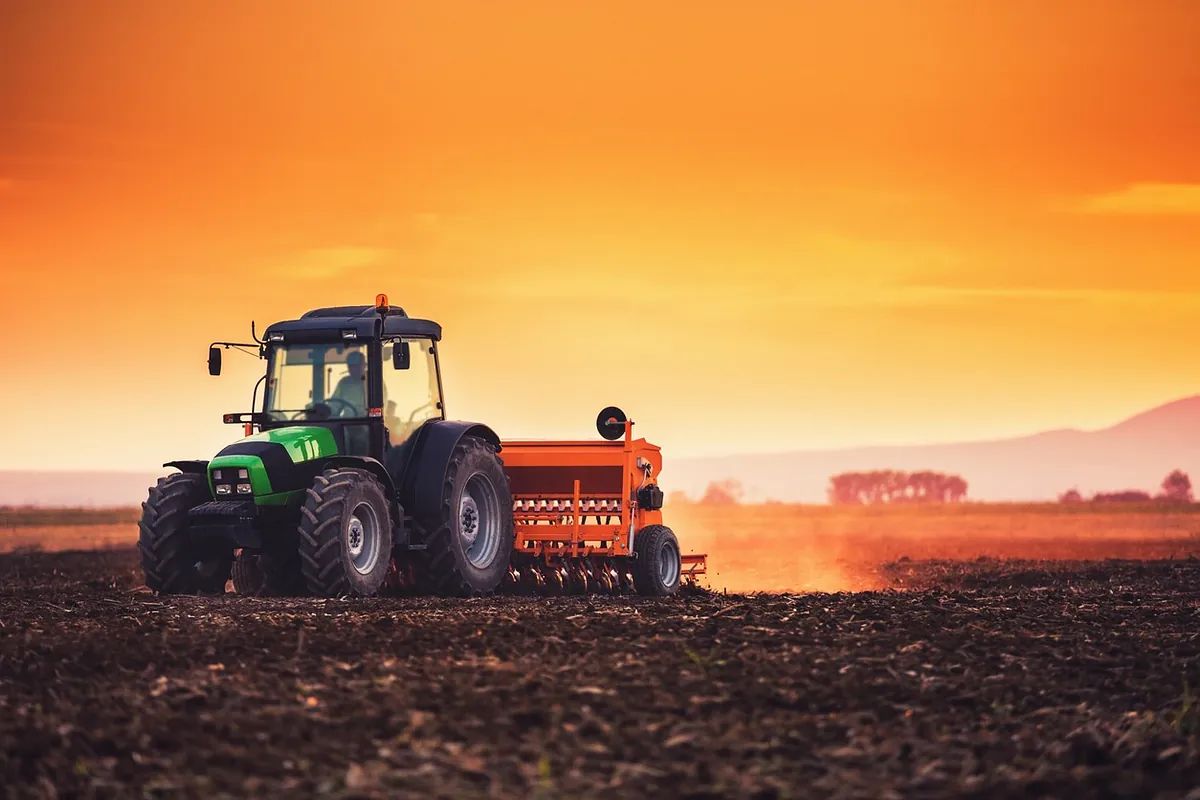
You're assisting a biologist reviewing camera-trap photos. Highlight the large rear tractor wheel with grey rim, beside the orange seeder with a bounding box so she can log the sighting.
[421,435,515,597]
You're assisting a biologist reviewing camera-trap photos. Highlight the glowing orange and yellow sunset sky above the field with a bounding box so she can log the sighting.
[0,0,1200,470]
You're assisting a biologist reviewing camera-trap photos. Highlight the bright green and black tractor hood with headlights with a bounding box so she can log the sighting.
[209,426,337,504]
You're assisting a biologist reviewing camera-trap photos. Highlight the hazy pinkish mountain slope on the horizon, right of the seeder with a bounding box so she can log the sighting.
[661,396,1200,503]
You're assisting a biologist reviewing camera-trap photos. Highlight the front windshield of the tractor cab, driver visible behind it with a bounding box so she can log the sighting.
[266,343,368,420]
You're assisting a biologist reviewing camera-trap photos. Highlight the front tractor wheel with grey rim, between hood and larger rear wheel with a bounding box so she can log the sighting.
[299,468,391,597]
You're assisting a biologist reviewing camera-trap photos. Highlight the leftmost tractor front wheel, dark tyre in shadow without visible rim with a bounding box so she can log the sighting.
[138,473,233,595]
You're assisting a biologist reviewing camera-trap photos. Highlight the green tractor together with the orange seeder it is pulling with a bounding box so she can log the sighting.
[138,294,707,597]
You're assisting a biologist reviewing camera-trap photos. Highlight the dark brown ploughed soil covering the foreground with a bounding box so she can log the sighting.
[0,551,1200,799]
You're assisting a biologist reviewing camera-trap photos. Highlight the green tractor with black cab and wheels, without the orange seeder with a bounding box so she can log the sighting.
[138,295,514,597]
